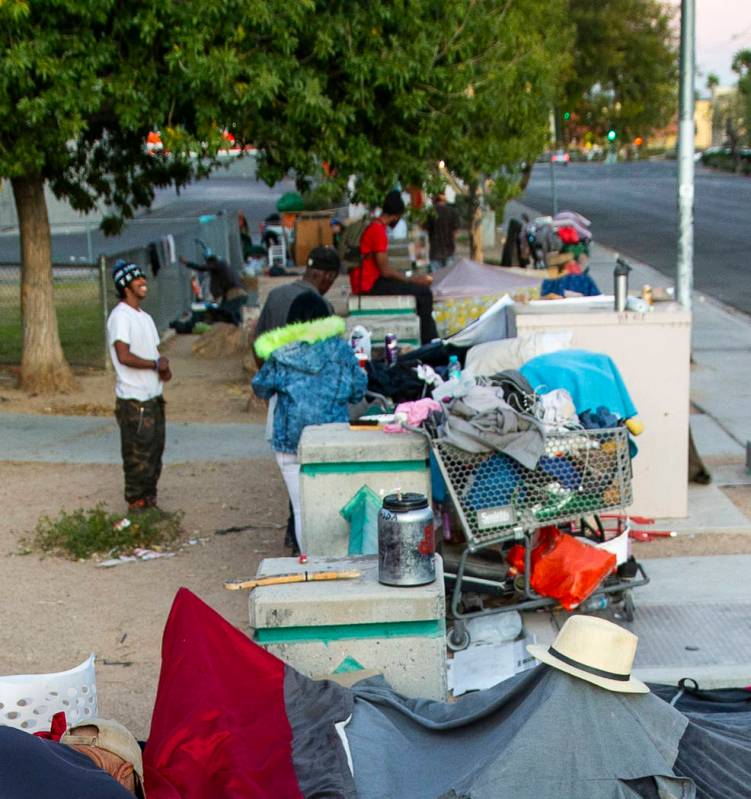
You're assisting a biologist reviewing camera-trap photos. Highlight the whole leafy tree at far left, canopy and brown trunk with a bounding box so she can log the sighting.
[0,0,311,391]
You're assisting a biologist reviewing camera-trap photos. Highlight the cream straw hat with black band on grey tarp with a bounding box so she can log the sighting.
[527,615,649,694]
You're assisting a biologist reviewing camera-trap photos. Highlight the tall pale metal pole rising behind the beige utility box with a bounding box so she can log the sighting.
[676,0,696,310]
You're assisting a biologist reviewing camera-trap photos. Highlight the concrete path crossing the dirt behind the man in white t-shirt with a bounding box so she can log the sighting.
[0,414,272,464]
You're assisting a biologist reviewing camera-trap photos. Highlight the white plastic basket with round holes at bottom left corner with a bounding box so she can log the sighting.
[0,654,97,732]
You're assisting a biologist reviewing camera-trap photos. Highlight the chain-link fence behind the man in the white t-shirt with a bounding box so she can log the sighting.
[0,212,243,368]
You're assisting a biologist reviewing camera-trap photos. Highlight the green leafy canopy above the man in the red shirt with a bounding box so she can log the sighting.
[246,0,567,256]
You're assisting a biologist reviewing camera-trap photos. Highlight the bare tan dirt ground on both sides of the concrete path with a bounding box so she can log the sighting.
[0,328,751,738]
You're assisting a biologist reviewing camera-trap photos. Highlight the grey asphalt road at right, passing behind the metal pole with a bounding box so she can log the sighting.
[521,161,751,313]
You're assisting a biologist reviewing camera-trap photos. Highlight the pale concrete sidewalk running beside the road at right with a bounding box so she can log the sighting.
[507,202,751,688]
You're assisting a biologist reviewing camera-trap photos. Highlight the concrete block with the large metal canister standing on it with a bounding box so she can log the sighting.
[249,556,447,700]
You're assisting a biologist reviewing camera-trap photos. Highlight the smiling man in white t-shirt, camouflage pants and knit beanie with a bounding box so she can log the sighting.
[107,259,172,511]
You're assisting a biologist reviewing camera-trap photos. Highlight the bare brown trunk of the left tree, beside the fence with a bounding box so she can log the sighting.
[11,175,75,394]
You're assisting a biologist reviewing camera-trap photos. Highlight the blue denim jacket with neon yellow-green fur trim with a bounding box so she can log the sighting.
[252,316,368,453]
